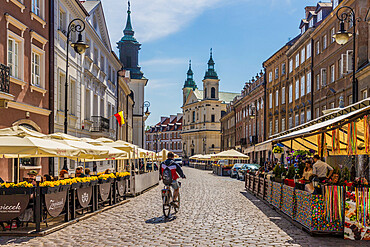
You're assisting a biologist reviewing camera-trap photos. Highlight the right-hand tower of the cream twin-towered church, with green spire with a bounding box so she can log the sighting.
[203,48,220,100]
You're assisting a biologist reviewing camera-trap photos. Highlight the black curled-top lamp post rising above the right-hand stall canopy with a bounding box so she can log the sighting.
[333,6,360,104]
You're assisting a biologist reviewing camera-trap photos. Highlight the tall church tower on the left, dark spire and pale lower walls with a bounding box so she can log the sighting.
[117,2,148,147]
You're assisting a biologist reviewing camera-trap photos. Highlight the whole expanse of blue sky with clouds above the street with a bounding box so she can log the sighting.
[102,0,320,125]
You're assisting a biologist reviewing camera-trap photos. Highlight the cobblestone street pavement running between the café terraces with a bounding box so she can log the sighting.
[0,168,367,247]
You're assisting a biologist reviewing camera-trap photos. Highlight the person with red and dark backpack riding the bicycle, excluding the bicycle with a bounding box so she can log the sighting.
[160,152,186,201]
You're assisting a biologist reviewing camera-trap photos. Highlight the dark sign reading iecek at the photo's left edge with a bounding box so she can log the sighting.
[0,195,30,221]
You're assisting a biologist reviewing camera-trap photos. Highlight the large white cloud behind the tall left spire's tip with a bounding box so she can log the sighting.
[102,0,221,48]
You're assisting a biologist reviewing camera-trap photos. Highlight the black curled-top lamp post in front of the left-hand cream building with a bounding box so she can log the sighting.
[63,18,89,170]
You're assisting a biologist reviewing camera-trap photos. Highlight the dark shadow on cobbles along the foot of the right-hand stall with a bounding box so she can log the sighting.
[240,191,364,246]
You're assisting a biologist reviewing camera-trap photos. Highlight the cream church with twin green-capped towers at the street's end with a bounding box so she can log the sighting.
[181,53,239,159]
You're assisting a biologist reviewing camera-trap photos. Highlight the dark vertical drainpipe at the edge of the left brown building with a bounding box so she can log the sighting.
[48,0,54,176]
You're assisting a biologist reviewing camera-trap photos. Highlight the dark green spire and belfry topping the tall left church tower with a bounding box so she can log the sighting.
[117,1,144,79]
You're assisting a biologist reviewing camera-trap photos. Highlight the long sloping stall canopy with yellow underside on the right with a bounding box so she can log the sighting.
[268,99,370,156]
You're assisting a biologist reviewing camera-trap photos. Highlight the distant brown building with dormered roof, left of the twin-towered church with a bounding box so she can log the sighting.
[145,113,183,156]
